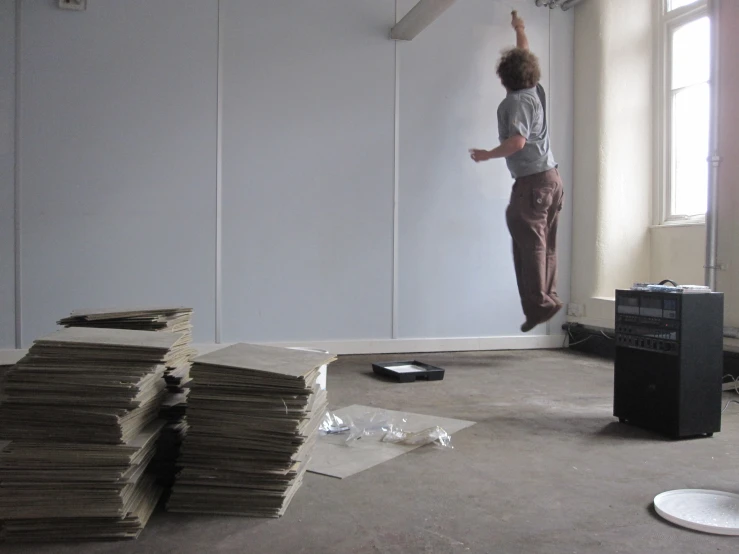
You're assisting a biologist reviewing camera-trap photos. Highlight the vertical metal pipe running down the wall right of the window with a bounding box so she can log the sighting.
[705,0,721,291]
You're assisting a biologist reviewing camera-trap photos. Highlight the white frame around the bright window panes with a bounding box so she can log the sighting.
[653,0,714,226]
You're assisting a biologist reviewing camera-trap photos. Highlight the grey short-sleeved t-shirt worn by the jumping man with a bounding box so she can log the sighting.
[498,85,557,179]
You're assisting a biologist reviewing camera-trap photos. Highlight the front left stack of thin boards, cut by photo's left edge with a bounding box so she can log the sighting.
[0,328,189,541]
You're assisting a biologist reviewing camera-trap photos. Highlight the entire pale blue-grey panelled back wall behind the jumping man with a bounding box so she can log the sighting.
[3,0,573,350]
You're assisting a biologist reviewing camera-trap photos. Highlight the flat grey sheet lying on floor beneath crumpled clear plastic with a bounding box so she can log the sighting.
[308,405,475,479]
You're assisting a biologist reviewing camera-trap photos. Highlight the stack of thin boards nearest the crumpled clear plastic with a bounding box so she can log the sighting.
[168,344,334,517]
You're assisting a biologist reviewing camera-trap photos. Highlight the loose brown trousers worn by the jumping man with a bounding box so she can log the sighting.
[506,169,564,324]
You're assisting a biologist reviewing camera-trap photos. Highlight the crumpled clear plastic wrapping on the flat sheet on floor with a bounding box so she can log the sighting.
[320,409,453,448]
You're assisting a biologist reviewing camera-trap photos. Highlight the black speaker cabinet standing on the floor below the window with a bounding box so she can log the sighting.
[613,290,724,439]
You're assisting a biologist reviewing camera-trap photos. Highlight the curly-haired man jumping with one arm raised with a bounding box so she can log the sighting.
[470,11,563,332]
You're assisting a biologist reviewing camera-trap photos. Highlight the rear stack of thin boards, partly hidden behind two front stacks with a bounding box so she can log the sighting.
[58,306,196,494]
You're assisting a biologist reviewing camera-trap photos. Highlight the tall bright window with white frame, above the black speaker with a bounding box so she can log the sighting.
[657,0,711,223]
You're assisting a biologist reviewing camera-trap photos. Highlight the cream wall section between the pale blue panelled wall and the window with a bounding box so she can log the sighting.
[572,0,653,326]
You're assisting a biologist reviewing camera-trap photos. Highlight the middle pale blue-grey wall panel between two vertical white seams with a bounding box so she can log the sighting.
[221,0,395,341]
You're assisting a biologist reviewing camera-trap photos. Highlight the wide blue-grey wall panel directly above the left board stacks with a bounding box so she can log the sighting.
[19,0,218,345]
